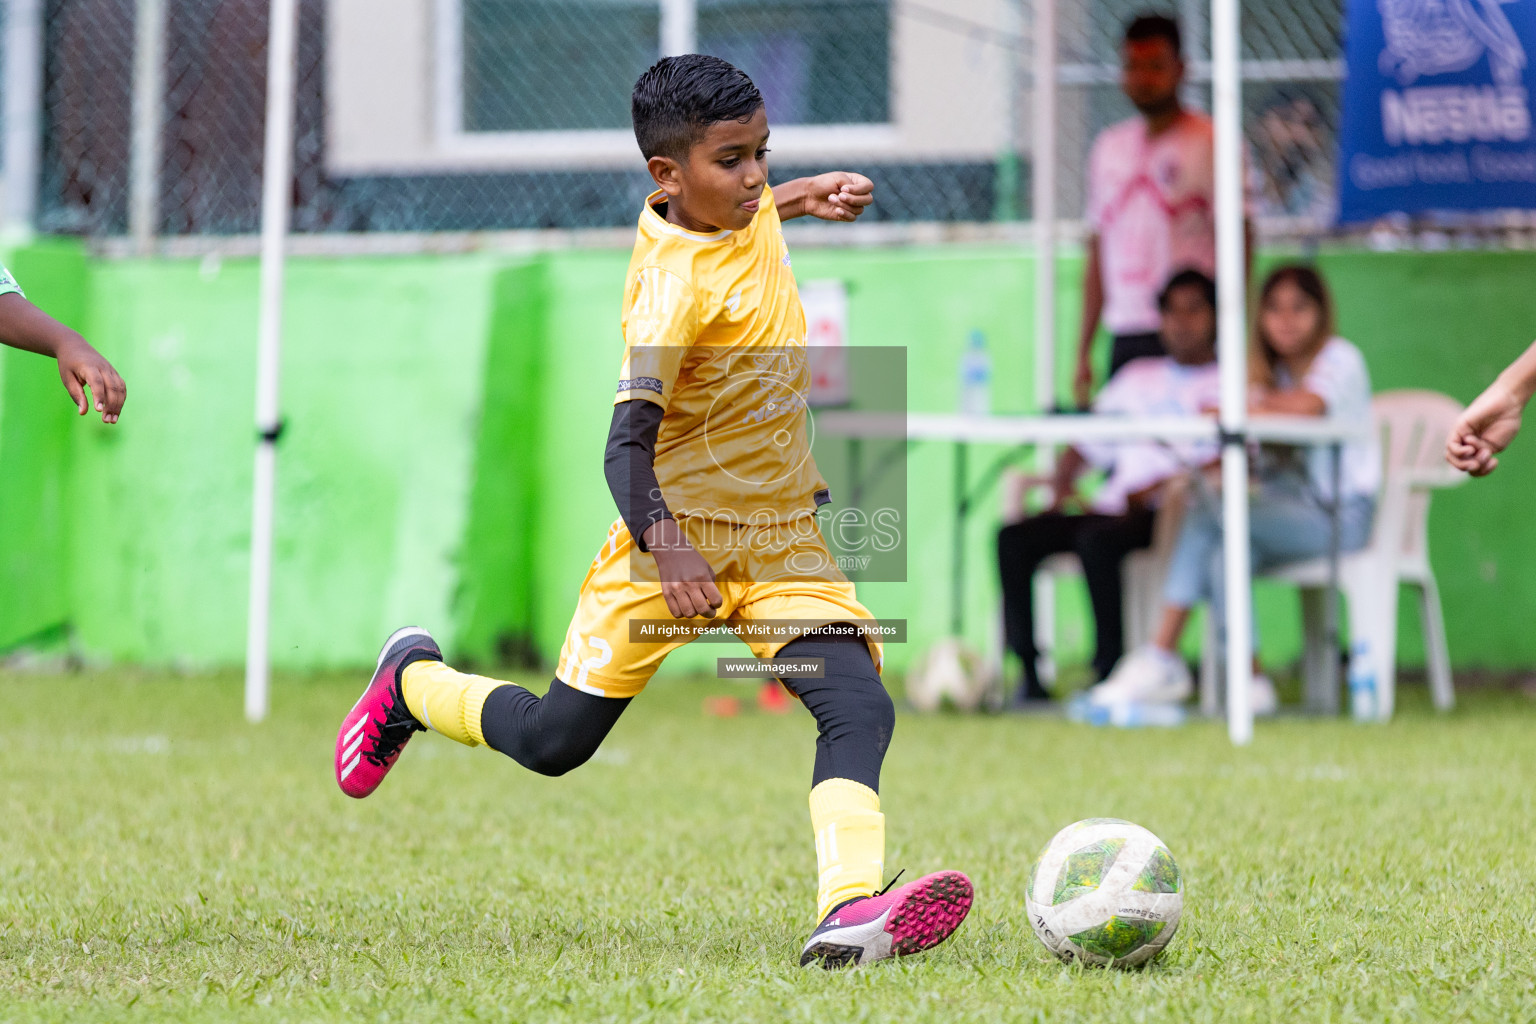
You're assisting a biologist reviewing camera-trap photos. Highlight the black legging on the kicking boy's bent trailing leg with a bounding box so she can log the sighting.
[481,679,631,775]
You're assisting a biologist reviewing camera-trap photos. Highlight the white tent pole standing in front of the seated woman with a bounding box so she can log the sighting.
[1210,0,1253,746]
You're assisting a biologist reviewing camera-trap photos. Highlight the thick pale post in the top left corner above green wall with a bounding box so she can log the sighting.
[0,0,43,238]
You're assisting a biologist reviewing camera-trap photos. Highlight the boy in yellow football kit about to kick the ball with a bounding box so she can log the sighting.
[335,54,972,967]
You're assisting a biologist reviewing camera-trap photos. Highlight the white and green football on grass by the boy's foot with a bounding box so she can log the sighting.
[1025,818,1184,967]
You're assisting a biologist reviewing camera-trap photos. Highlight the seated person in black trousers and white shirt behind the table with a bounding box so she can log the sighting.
[997,270,1221,703]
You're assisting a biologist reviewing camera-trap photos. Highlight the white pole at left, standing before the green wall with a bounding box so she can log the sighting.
[246,0,298,722]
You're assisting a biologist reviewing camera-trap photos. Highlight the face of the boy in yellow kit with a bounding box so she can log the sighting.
[647,107,768,232]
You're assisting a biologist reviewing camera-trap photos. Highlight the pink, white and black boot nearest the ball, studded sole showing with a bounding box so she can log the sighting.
[800,870,974,970]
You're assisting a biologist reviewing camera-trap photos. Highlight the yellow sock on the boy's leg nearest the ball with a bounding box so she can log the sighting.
[811,778,885,921]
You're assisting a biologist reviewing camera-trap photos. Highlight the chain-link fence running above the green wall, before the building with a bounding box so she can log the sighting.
[21,0,1342,236]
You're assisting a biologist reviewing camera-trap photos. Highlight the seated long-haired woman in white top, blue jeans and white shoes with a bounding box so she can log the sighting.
[1089,266,1381,714]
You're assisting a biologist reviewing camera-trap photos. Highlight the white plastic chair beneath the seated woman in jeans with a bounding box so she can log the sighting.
[1201,390,1467,722]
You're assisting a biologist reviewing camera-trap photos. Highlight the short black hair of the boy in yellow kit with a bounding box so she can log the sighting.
[630,54,763,160]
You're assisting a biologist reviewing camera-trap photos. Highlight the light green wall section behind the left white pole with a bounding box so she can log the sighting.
[61,258,502,668]
